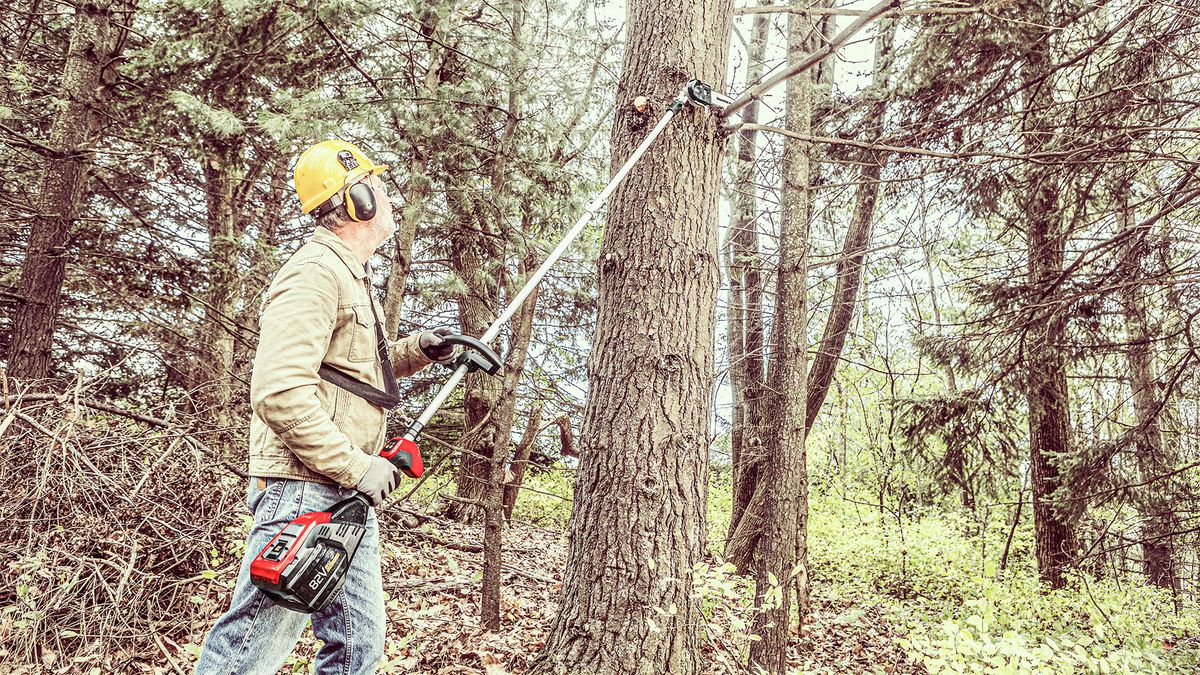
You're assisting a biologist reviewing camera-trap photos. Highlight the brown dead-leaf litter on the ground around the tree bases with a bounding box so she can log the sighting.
[181,509,925,675]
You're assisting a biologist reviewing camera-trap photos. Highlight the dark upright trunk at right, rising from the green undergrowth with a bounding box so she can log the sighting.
[1021,31,1079,589]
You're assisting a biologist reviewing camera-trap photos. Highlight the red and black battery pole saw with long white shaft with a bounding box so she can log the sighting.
[250,79,732,613]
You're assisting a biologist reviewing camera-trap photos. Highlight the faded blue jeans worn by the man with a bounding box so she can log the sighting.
[196,478,384,675]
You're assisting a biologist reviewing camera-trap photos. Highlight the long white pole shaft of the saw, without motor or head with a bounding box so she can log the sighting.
[404,86,688,441]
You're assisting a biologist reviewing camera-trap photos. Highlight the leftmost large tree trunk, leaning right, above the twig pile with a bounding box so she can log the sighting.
[7,0,136,380]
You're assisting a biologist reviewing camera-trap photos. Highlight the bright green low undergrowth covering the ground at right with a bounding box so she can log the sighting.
[809,497,1200,674]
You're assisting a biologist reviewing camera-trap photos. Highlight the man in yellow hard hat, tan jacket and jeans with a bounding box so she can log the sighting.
[196,141,454,675]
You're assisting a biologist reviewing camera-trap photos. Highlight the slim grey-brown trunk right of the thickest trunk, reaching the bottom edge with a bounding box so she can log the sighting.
[749,14,815,674]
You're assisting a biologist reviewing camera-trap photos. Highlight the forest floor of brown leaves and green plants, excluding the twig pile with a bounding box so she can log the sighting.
[179,473,1200,675]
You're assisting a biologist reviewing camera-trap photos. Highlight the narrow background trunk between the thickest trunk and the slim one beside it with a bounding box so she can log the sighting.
[726,0,770,540]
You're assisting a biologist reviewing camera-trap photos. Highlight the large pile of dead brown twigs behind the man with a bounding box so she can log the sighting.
[0,383,246,673]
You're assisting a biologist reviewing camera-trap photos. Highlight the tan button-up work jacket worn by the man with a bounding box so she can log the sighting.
[250,227,431,488]
